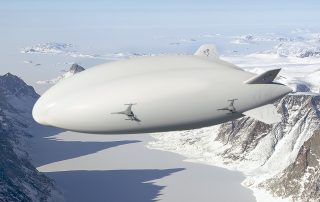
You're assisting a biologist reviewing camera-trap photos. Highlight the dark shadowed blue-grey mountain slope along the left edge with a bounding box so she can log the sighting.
[0,73,62,202]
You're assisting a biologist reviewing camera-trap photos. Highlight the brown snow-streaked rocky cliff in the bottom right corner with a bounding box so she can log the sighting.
[259,130,320,201]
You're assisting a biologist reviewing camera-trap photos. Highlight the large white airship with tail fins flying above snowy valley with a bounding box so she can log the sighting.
[32,44,292,134]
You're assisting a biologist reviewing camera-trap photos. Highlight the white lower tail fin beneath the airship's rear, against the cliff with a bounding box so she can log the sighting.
[243,104,281,124]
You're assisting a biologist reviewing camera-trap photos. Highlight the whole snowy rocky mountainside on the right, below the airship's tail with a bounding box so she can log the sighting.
[149,93,320,202]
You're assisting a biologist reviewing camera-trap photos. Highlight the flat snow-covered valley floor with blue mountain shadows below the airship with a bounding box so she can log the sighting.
[31,132,255,202]
